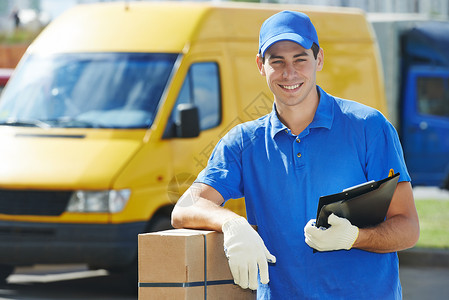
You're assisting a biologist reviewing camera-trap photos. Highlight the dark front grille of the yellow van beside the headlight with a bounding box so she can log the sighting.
[0,189,72,216]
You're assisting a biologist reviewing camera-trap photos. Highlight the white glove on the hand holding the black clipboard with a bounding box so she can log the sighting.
[304,214,359,251]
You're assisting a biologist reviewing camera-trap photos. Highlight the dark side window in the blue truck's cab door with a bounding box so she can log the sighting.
[416,77,449,117]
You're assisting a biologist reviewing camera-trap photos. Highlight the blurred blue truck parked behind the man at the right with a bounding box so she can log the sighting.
[368,14,449,189]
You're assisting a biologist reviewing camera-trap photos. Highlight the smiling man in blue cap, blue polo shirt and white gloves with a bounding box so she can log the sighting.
[172,11,419,299]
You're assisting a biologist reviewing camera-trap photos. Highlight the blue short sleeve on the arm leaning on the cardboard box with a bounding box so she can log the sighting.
[195,126,244,201]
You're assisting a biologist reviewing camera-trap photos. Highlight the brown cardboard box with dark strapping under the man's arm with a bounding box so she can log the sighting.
[138,229,256,300]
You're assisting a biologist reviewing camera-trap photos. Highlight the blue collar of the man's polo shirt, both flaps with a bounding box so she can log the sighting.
[270,86,334,138]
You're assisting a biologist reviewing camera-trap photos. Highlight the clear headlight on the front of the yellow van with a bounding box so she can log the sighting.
[66,189,131,213]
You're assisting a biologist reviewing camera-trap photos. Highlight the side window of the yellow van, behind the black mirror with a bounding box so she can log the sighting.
[164,62,221,138]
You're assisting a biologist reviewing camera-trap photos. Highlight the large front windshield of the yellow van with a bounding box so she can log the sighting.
[0,53,177,128]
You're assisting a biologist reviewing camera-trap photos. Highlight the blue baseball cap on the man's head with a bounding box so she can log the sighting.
[259,10,320,57]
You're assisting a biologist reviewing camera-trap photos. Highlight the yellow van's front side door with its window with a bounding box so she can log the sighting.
[164,52,223,202]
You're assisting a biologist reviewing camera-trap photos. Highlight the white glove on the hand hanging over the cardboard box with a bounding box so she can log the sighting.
[222,217,276,290]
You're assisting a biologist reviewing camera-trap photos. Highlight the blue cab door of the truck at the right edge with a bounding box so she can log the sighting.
[401,67,449,186]
